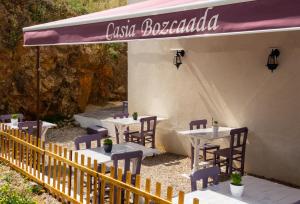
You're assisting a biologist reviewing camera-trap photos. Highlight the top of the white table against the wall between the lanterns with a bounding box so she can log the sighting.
[177,127,234,139]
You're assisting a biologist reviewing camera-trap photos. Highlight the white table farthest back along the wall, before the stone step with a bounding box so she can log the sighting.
[102,116,166,143]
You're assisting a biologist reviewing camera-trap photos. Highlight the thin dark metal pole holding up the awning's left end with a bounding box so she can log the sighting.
[35,47,41,146]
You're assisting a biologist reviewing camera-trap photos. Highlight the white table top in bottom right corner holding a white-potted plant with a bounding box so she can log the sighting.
[173,176,300,204]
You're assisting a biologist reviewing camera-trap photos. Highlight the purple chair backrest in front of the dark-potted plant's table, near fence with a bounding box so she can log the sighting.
[111,150,143,183]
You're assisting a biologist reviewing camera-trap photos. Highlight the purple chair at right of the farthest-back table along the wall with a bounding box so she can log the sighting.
[128,116,157,148]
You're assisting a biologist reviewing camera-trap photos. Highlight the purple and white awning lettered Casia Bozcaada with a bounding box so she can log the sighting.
[23,0,300,46]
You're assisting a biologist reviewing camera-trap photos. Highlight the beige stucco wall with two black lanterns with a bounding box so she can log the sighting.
[128,32,300,185]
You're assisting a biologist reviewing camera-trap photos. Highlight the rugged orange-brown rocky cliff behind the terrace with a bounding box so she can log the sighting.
[0,0,127,117]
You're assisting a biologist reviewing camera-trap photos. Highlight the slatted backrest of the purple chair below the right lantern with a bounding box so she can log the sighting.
[230,127,248,155]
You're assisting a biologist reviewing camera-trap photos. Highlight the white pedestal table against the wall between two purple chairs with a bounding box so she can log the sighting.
[177,127,233,172]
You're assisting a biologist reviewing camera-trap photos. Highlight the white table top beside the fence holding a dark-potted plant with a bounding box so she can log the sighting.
[74,142,159,163]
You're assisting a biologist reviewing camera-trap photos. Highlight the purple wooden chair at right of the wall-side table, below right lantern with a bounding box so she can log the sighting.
[214,127,248,175]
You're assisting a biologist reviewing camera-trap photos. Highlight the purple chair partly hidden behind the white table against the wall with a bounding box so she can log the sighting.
[190,120,220,168]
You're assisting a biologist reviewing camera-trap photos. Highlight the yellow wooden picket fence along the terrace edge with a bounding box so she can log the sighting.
[0,124,199,204]
